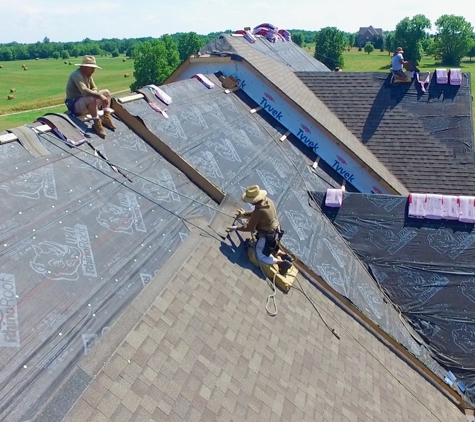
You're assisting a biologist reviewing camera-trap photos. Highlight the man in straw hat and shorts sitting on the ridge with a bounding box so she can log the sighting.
[65,55,115,138]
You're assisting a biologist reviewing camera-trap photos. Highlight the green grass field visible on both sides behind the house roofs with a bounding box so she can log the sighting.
[0,44,475,131]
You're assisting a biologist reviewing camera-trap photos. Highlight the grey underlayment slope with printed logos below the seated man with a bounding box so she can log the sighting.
[0,117,214,422]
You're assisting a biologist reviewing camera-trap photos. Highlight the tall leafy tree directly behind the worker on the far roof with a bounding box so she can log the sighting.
[393,15,432,64]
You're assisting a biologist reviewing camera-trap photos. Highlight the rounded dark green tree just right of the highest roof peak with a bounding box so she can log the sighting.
[314,26,348,69]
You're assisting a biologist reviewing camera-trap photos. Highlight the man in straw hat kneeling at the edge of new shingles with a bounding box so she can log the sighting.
[227,185,292,274]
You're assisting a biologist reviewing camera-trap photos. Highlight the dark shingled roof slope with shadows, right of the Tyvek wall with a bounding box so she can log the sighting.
[298,72,475,194]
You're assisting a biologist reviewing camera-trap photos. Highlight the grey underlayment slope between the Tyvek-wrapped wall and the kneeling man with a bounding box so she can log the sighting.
[123,75,445,378]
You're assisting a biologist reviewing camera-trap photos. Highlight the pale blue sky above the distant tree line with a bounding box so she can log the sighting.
[0,0,475,43]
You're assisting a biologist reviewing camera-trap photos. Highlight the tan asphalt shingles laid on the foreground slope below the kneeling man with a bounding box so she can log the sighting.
[65,234,465,422]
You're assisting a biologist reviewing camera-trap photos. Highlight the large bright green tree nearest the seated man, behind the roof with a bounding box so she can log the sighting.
[130,35,180,90]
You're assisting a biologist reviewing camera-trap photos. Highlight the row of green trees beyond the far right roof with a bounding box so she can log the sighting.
[312,14,475,69]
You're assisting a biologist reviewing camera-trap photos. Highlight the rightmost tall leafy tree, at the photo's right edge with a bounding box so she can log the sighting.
[435,15,473,66]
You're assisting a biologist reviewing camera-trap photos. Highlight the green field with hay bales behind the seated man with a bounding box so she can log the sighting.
[0,56,134,130]
